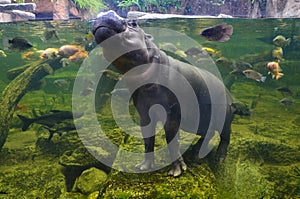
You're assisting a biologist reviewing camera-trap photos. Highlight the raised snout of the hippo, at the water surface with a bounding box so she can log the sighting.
[92,10,127,44]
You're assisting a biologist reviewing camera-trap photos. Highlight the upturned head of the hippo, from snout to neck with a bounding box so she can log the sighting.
[92,11,164,73]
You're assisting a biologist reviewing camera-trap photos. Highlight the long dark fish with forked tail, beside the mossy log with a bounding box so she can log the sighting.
[18,110,83,131]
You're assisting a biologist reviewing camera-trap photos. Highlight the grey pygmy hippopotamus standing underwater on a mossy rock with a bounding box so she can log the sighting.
[92,11,233,176]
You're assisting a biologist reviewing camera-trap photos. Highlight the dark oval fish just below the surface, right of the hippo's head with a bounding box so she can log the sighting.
[200,23,233,42]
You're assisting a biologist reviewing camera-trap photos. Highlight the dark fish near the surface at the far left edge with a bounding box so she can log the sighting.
[2,37,33,51]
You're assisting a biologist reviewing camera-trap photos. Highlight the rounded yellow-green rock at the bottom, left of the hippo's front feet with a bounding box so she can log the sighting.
[75,167,107,194]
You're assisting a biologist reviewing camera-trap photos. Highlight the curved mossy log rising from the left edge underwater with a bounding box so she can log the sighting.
[0,59,62,150]
